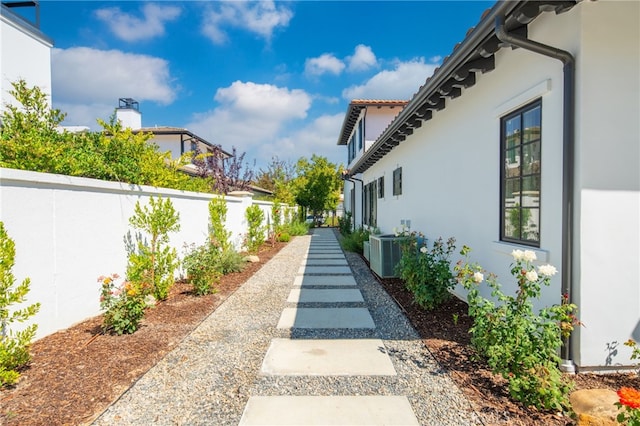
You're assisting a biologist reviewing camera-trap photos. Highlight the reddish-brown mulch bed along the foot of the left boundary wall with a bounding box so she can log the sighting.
[0,243,285,426]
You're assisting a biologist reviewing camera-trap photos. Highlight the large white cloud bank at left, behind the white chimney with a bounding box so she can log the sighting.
[51,47,177,126]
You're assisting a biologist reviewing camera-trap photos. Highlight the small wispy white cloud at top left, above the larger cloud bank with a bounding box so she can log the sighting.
[95,3,181,41]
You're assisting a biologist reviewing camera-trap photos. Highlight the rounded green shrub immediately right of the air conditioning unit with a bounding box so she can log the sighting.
[396,234,456,310]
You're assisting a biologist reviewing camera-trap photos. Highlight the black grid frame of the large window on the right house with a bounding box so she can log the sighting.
[499,98,542,248]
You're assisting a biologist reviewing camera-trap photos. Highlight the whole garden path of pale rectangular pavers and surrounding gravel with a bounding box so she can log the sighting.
[93,229,482,426]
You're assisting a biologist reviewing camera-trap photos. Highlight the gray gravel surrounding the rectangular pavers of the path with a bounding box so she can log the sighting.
[93,231,482,426]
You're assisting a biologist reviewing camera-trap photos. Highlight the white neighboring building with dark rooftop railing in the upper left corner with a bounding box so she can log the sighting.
[0,1,53,110]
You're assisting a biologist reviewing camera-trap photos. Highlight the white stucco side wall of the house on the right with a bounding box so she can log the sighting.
[363,1,640,367]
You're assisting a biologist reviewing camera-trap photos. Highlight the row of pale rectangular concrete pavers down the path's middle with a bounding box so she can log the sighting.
[240,229,419,426]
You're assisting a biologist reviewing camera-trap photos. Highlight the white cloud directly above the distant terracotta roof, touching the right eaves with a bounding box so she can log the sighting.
[342,58,438,100]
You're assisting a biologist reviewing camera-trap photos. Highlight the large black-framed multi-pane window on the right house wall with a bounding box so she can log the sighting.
[500,100,542,247]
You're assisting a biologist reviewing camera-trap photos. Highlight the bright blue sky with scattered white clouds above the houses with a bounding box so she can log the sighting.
[40,0,493,169]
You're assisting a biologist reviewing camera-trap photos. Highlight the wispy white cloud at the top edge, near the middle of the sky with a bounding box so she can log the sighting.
[202,0,293,44]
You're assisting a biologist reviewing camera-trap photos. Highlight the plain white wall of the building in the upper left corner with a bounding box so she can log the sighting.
[0,9,52,109]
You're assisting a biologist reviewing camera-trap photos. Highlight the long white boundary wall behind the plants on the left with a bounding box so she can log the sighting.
[0,168,273,338]
